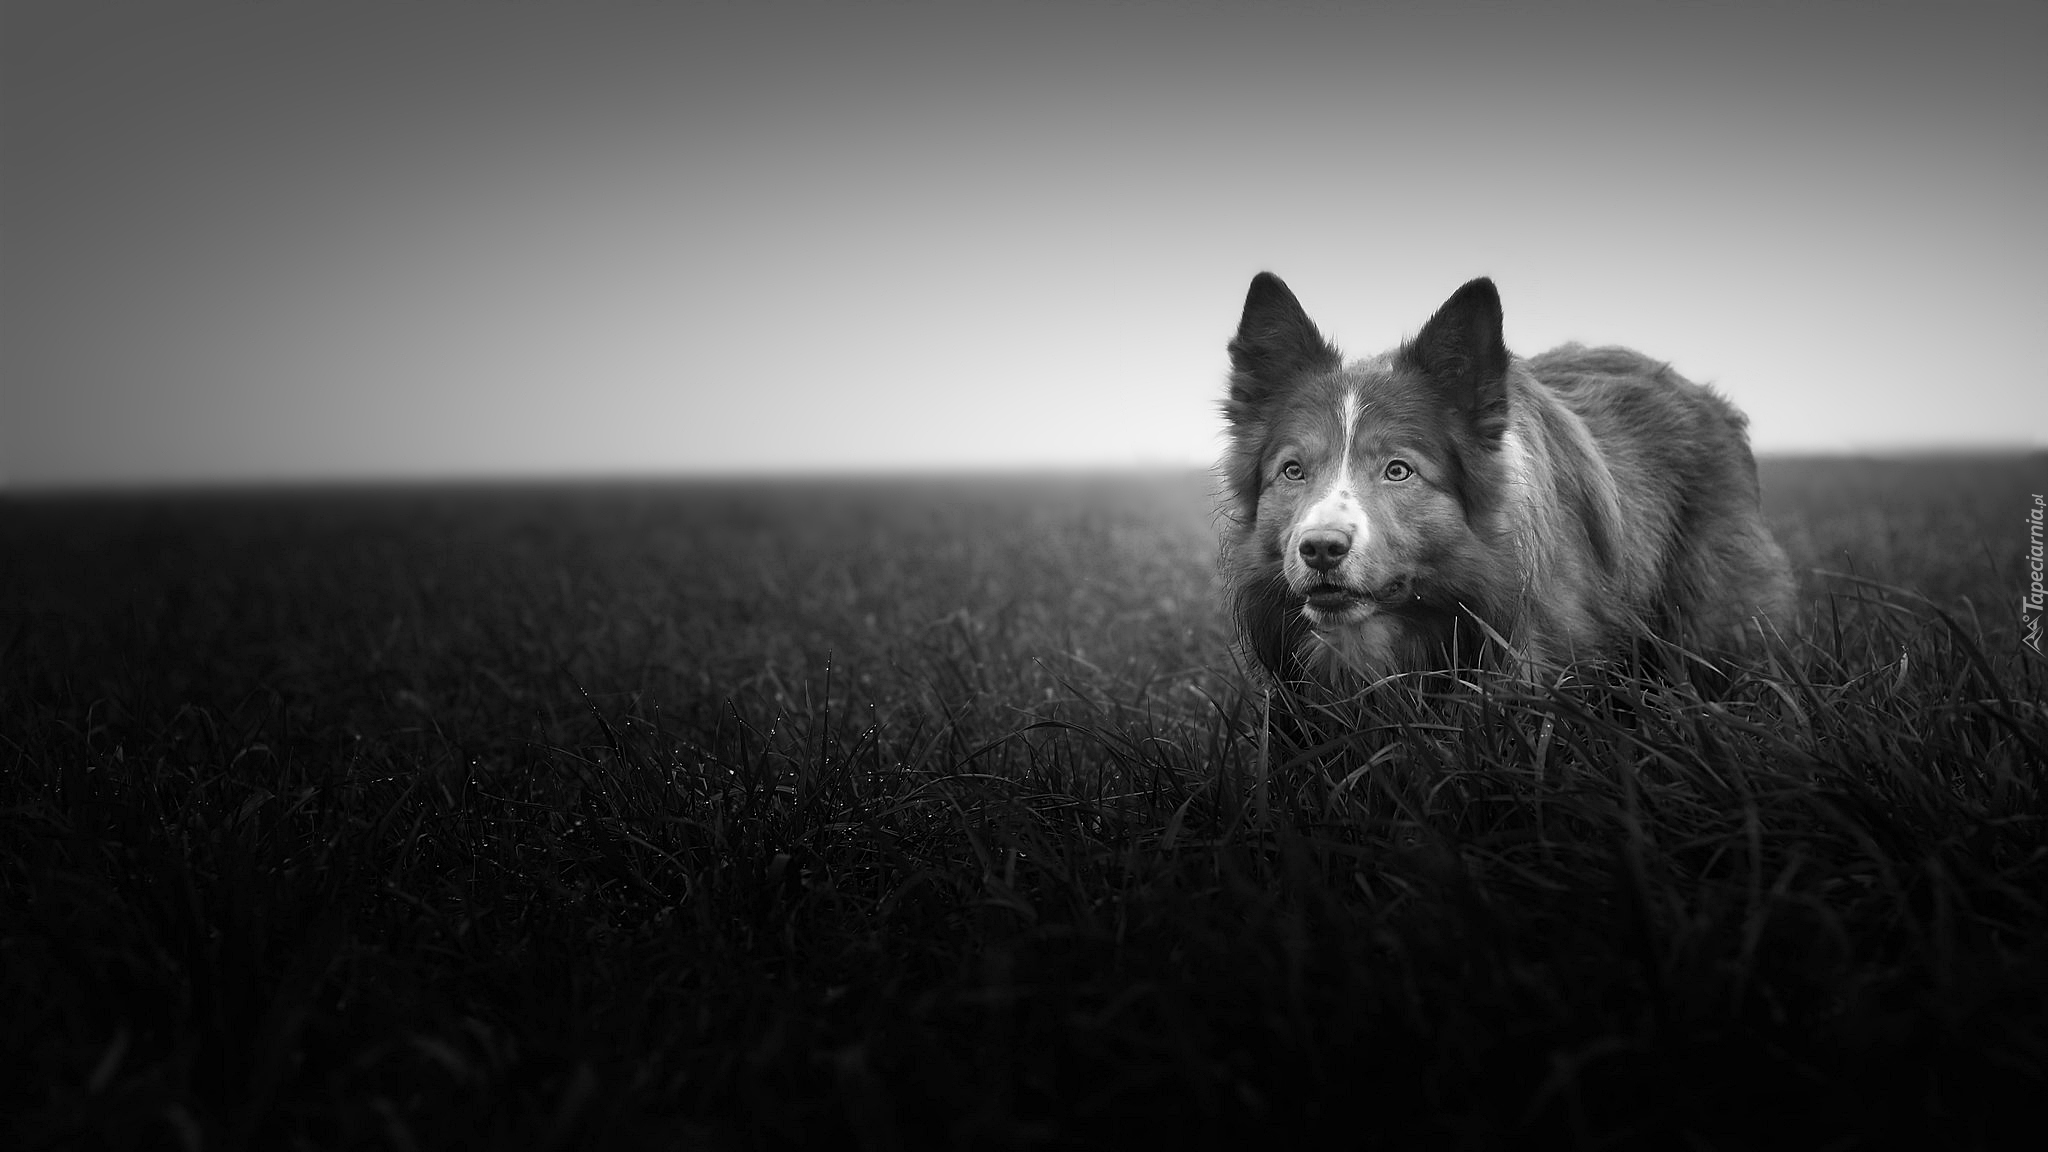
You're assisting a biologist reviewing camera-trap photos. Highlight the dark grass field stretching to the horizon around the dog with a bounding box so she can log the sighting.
[0,455,2048,1148]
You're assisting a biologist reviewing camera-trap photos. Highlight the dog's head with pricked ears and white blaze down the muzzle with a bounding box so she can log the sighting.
[1223,273,1511,670]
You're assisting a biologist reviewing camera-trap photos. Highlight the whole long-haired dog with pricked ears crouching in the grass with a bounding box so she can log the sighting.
[1221,273,1792,687]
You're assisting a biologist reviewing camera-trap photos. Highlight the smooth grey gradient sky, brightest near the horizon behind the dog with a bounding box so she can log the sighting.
[0,0,2048,486]
